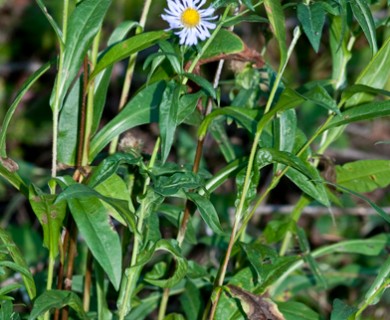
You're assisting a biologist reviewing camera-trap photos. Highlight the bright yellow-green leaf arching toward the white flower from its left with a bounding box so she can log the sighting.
[90,31,169,80]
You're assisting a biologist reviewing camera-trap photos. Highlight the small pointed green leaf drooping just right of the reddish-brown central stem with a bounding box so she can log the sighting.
[186,192,223,235]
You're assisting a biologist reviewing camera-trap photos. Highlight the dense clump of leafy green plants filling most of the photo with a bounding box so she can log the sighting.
[0,0,390,320]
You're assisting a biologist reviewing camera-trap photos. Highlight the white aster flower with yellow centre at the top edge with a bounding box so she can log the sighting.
[161,0,217,46]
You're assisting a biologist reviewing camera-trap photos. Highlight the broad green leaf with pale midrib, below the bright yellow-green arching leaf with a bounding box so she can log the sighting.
[89,81,165,161]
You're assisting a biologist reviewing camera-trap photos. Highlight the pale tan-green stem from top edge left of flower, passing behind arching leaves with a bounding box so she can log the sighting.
[109,0,152,154]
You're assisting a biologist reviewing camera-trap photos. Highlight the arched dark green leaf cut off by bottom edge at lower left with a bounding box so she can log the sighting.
[28,290,89,320]
